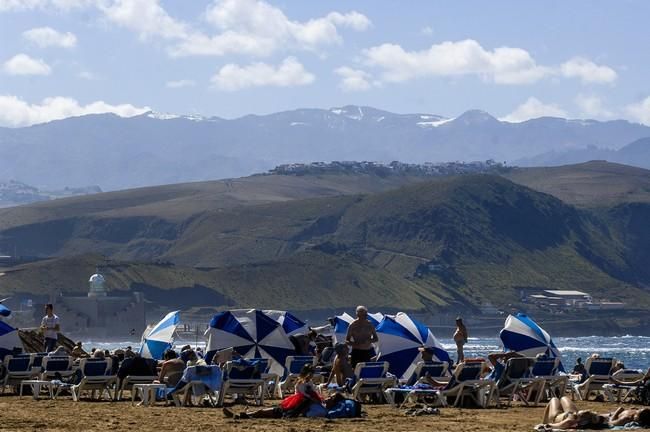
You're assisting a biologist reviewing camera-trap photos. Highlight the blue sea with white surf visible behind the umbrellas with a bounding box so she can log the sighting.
[78,336,650,370]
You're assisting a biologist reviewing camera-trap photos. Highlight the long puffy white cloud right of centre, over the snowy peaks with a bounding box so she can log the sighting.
[364,39,551,84]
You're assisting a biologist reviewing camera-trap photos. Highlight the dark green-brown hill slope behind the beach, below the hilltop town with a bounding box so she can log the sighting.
[0,175,650,318]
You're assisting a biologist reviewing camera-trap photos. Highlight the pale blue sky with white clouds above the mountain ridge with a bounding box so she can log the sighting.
[0,0,650,127]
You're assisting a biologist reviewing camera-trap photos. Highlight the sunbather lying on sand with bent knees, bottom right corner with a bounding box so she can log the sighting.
[543,396,650,429]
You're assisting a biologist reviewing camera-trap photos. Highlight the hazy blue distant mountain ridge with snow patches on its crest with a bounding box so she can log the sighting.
[0,105,650,190]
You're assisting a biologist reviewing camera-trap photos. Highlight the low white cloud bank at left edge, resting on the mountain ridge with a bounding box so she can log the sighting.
[0,95,151,127]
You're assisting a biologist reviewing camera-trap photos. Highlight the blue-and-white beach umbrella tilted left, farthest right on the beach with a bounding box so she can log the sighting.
[499,313,562,369]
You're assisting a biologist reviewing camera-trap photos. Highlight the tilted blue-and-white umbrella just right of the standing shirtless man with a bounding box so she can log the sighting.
[377,312,451,379]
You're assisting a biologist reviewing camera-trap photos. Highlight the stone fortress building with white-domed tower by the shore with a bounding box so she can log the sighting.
[52,270,146,338]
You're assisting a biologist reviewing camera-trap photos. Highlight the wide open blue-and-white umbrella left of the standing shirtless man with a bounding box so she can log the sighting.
[205,309,295,376]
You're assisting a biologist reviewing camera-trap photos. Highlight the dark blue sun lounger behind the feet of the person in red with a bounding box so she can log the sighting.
[218,360,265,406]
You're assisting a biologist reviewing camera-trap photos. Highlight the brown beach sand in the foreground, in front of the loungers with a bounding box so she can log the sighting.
[0,396,644,432]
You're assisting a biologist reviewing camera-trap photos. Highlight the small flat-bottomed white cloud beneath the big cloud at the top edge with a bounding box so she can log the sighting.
[210,57,315,91]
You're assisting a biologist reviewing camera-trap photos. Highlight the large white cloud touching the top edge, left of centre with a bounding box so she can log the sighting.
[170,0,371,57]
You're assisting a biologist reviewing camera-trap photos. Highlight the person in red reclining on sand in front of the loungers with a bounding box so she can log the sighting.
[223,364,323,419]
